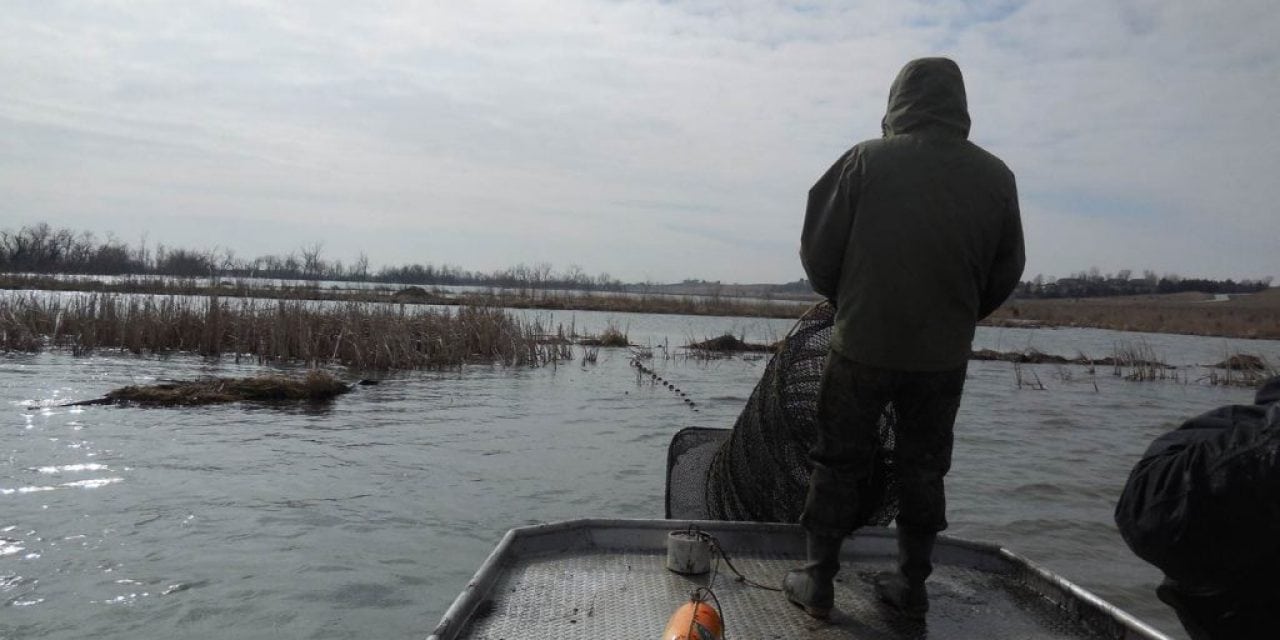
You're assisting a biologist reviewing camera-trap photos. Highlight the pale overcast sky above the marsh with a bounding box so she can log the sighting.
[0,0,1280,283]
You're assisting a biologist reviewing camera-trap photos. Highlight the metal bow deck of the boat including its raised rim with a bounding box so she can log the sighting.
[431,521,1166,640]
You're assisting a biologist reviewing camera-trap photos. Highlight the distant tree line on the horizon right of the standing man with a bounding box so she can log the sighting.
[1014,266,1271,298]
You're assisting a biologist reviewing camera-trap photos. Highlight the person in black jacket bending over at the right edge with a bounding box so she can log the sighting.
[1115,376,1280,640]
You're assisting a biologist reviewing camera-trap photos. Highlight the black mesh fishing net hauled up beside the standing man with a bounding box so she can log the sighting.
[667,303,897,525]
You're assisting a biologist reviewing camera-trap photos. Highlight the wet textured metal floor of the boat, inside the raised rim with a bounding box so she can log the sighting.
[461,549,1108,640]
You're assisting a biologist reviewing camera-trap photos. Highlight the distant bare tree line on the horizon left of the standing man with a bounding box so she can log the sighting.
[0,223,623,291]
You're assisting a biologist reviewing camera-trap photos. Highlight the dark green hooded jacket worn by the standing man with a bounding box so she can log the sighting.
[800,58,1025,371]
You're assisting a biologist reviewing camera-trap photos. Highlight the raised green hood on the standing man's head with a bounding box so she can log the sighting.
[881,58,969,138]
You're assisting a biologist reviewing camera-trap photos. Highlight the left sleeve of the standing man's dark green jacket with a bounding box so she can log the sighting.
[800,146,858,300]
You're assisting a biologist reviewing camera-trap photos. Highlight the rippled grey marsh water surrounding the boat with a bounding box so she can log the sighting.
[0,307,1280,639]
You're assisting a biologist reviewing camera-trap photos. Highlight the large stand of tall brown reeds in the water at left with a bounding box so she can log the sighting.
[0,294,560,370]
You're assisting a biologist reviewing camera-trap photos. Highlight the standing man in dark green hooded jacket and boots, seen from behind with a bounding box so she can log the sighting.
[783,58,1024,617]
